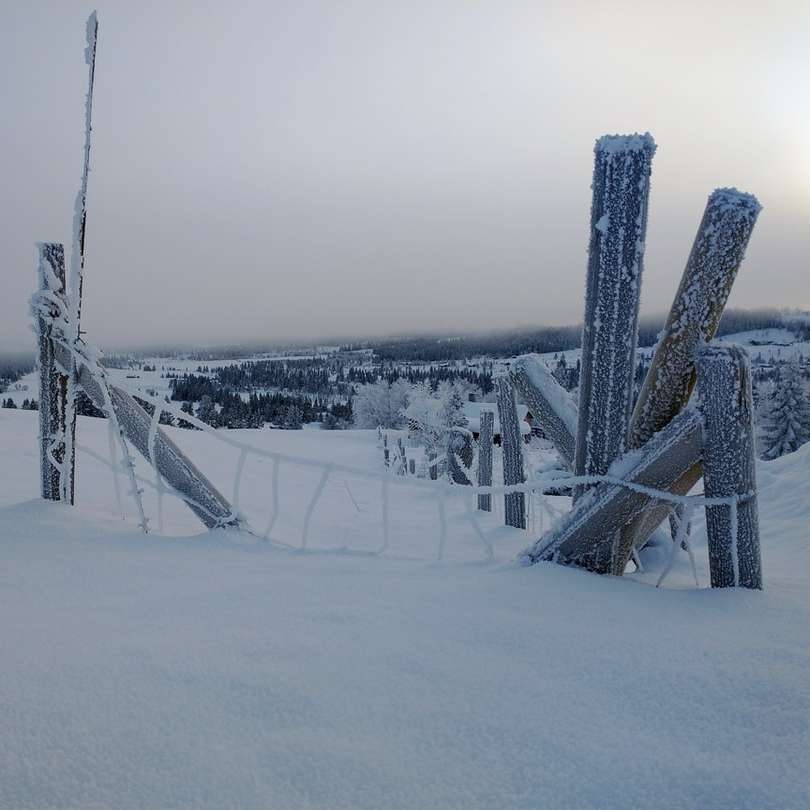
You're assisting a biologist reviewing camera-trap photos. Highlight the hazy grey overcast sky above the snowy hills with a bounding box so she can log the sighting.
[0,0,810,350]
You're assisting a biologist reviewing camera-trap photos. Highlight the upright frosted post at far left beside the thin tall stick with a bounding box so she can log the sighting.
[37,242,75,504]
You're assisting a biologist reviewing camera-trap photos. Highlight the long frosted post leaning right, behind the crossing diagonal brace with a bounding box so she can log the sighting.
[614,188,761,573]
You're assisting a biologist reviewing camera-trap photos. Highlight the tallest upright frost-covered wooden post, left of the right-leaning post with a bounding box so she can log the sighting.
[574,133,655,494]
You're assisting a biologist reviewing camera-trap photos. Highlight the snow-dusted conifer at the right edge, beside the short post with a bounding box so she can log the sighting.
[761,363,810,459]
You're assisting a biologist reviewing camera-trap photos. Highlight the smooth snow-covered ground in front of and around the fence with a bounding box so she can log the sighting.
[0,410,810,810]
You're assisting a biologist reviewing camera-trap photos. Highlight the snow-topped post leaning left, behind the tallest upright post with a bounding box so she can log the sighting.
[509,354,577,467]
